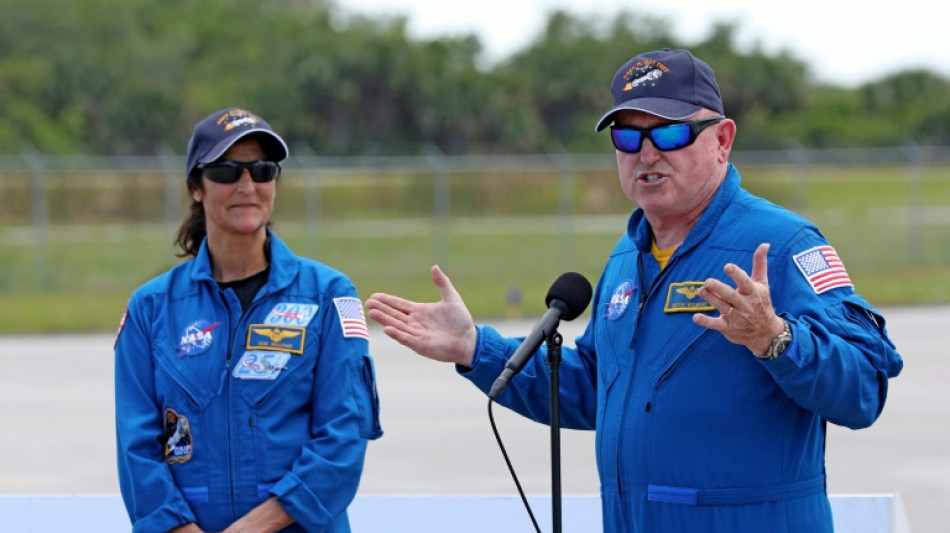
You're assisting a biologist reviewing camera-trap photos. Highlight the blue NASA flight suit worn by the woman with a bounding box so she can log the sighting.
[115,234,382,533]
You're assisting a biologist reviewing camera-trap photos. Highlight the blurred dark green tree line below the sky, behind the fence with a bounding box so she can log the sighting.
[0,0,950,155]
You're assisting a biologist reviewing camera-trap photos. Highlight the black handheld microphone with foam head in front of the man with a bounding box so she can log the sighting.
[488,272,594,400]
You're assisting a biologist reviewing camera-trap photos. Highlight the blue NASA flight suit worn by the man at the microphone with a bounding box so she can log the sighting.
[459,165,903,533]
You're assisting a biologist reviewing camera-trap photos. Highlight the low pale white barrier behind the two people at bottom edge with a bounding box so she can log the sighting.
[0,494,910,533]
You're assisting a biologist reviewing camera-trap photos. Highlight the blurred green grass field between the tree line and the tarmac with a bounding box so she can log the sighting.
[0,161,950,333]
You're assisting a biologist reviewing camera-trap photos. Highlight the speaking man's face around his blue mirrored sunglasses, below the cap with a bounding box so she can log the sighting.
[615,111,735,225]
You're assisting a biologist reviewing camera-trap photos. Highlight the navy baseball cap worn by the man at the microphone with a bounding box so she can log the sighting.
[594,48,725,131]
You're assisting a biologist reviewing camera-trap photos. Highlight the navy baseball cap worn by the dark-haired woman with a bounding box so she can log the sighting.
[185,107,289,177]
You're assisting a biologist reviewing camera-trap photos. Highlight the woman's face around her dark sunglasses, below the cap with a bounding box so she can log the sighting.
[191,137,277,238]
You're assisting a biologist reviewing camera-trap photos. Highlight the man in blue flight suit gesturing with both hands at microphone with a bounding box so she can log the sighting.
[367,50,903,533]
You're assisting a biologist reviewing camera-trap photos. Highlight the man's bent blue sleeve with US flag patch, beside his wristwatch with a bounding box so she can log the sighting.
[763,231,903,429]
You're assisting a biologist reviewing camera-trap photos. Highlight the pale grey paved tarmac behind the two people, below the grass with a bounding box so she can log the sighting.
[0,307,950,533]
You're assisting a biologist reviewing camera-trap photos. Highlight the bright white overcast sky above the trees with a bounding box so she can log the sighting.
[337,0,950,86]
